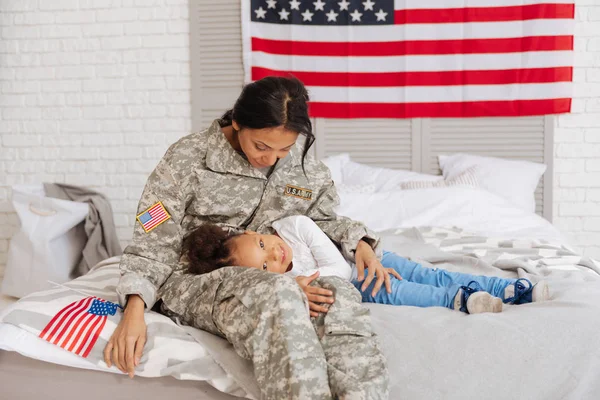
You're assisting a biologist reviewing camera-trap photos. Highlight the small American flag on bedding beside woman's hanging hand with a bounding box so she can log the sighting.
[39,297,119,358]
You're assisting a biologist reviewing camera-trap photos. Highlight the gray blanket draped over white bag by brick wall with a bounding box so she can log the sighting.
[44,183,123,277]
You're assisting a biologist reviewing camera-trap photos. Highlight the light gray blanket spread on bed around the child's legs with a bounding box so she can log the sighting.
[370,228,600,400]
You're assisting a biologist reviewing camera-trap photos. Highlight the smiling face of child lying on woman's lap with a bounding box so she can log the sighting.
[233,232,293,274]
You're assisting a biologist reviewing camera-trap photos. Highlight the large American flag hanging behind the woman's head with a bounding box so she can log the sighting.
[242,0,575,118]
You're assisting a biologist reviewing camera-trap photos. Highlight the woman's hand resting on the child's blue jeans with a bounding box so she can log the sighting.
[355,240,402,296]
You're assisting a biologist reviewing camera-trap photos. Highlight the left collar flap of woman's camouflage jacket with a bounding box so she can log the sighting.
[206,120,267,179]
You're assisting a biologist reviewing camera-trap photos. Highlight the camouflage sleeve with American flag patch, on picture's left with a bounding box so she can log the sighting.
[117,157,186,310]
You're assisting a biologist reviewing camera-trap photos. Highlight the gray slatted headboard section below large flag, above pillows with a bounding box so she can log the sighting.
[314,117,554,221]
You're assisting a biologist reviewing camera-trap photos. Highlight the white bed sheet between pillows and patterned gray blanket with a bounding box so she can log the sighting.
[337,187,568,245]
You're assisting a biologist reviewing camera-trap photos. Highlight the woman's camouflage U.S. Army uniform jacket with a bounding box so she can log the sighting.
[117,121,378,313]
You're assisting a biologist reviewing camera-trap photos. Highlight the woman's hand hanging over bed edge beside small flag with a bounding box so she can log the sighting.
[104,295,146,378]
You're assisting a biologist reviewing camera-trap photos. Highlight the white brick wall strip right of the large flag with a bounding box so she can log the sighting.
[554,0,600,259]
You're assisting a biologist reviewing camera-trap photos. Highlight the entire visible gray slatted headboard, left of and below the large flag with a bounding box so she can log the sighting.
[189,0,554,220]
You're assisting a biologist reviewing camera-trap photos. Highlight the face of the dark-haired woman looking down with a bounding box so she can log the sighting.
[233,121,298,168]
